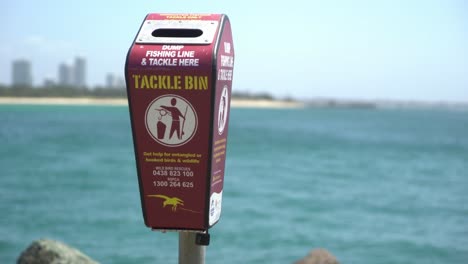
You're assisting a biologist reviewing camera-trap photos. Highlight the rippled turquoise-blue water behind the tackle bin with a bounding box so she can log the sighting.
[0,105,468,264]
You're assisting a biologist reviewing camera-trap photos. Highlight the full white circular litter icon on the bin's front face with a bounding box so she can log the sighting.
[145,94,198,147]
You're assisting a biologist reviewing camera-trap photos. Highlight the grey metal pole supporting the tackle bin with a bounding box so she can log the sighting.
[179,232,206,264]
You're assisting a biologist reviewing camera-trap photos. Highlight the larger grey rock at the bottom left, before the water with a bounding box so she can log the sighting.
[16,239,98,264]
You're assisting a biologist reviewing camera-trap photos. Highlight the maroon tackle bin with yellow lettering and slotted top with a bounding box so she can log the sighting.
[125,14,234,232]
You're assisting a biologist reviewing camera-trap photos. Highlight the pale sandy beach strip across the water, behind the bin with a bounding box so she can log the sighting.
[0,97,304,108]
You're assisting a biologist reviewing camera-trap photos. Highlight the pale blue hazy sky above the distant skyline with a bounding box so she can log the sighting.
[0,0,468,102]
